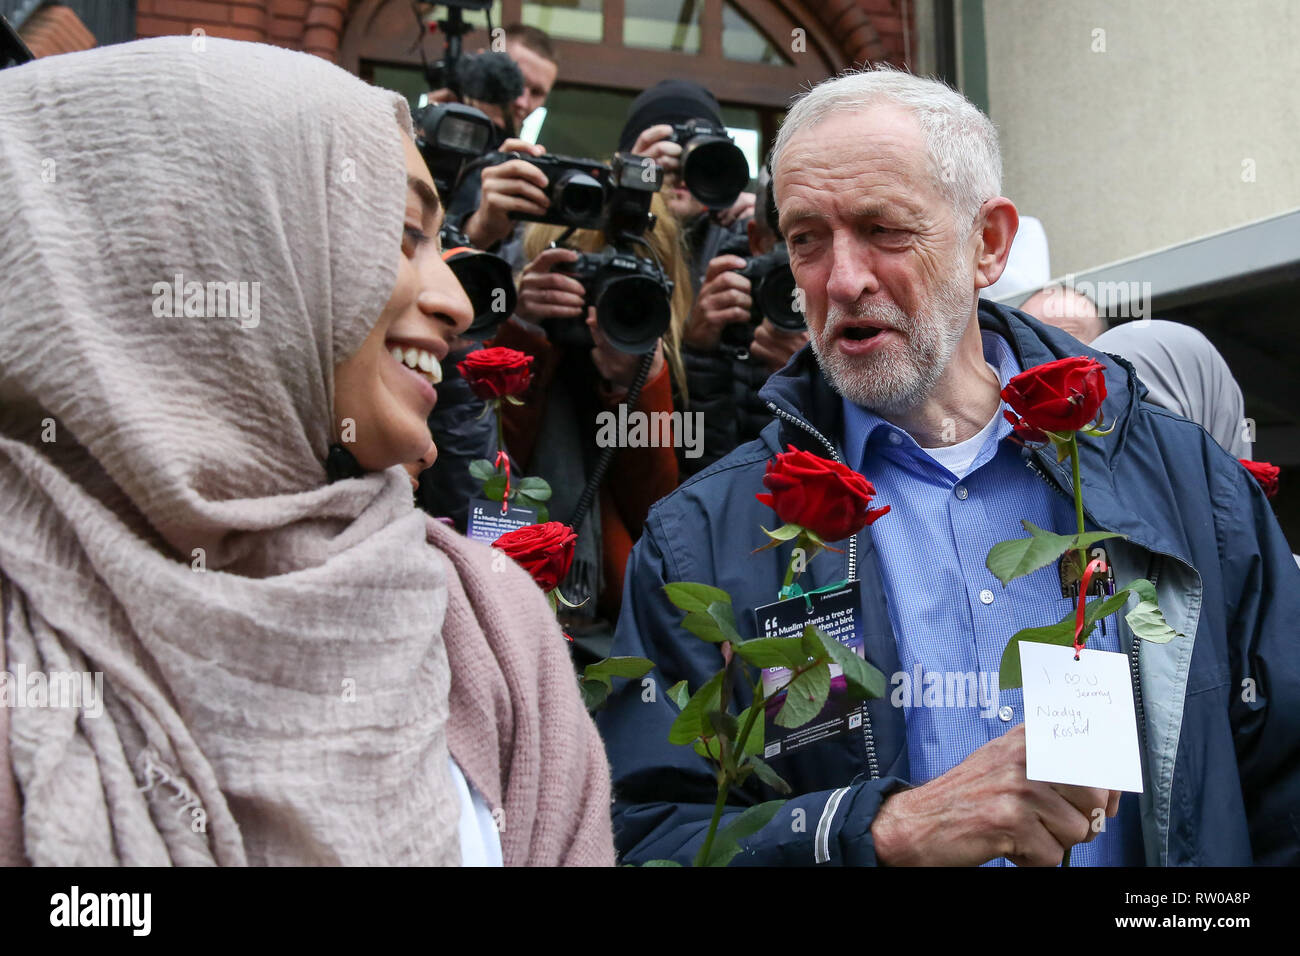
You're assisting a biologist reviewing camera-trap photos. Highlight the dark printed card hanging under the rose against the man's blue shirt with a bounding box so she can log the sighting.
[754,581,866,760]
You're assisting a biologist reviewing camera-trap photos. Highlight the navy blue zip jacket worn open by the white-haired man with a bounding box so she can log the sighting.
[598,300,1300,866]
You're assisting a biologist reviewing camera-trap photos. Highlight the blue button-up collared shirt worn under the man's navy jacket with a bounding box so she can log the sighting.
[844,330,1143,866]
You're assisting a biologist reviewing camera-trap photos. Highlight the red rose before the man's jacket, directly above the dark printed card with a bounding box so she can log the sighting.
[754,445,889,541]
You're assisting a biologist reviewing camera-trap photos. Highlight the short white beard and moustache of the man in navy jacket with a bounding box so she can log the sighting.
[809,260,975,418]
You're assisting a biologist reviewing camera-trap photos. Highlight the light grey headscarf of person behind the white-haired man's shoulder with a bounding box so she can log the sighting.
[1091,319,1251,459]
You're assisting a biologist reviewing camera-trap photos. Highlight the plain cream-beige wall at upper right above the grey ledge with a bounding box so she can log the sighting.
[984,0,1300,276]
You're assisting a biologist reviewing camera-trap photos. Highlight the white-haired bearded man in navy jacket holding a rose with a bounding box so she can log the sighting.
[599,70,1300,866]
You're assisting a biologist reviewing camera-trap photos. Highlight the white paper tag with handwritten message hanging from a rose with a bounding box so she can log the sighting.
[1021,641,1141,793]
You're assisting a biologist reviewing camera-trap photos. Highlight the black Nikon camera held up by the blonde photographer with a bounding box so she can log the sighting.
[555,246,673,355]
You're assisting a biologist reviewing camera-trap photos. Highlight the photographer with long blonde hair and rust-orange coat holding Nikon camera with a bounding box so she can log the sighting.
[493,189,690,644]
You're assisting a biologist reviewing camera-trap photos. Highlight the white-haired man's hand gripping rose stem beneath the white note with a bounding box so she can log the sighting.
[871,724,1119,866]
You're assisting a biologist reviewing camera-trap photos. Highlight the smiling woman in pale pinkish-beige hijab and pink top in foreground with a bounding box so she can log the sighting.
[0,36,614,865]
